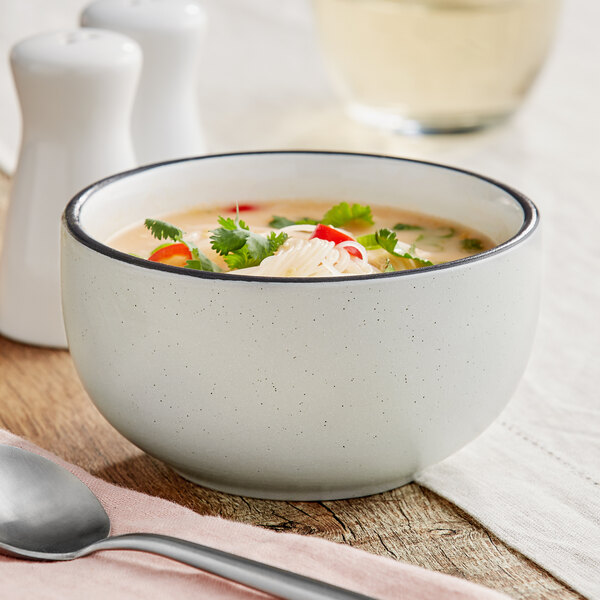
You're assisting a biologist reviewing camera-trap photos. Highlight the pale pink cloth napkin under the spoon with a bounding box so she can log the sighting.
[0,430,507,600]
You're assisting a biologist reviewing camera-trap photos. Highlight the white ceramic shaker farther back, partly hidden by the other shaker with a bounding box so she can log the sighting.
[81,0,206,164]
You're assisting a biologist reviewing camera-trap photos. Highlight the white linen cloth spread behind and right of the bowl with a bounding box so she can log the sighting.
[0,0,600,598]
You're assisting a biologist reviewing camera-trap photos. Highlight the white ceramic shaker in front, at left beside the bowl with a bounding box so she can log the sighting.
[0,29,142,348]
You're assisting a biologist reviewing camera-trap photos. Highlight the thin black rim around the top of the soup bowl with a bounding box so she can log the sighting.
[63,150,539,283]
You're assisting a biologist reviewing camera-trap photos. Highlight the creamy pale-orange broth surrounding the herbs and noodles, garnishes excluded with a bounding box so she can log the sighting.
[106,201,494,276]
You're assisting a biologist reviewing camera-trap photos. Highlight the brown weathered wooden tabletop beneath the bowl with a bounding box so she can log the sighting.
[0,175,581,600]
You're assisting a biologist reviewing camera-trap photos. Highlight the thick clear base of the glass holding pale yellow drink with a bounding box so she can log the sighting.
[348,103,512,135]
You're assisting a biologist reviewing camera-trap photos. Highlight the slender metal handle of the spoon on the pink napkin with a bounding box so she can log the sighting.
[86,533,373,600]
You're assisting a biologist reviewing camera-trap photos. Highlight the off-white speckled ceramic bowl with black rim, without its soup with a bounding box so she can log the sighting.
[62,152,540,500]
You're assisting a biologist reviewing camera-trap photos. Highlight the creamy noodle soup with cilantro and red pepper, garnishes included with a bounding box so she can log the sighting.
[106,201,494,277]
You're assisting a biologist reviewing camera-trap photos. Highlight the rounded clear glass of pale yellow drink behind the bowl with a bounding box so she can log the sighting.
[314,0,559,131]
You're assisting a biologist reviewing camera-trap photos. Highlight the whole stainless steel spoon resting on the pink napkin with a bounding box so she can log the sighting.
[0,445,372,600]
